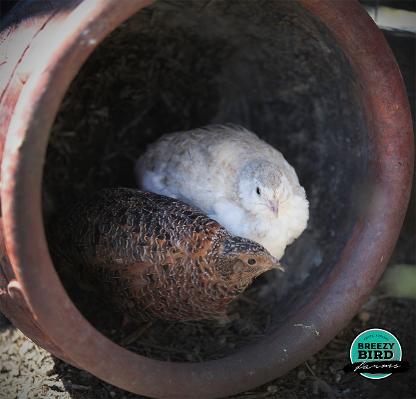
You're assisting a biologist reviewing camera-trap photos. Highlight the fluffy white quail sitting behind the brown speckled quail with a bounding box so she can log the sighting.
[135,125,309,259]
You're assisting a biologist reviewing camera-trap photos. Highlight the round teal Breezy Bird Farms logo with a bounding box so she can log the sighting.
[350,328,402,380]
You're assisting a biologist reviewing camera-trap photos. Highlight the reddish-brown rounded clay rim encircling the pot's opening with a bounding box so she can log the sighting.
[1,0,413,398]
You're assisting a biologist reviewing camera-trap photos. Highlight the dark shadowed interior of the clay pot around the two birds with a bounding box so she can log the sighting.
[44,0,368,361]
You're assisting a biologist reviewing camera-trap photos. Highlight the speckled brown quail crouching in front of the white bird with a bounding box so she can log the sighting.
[51,188,278,320]
